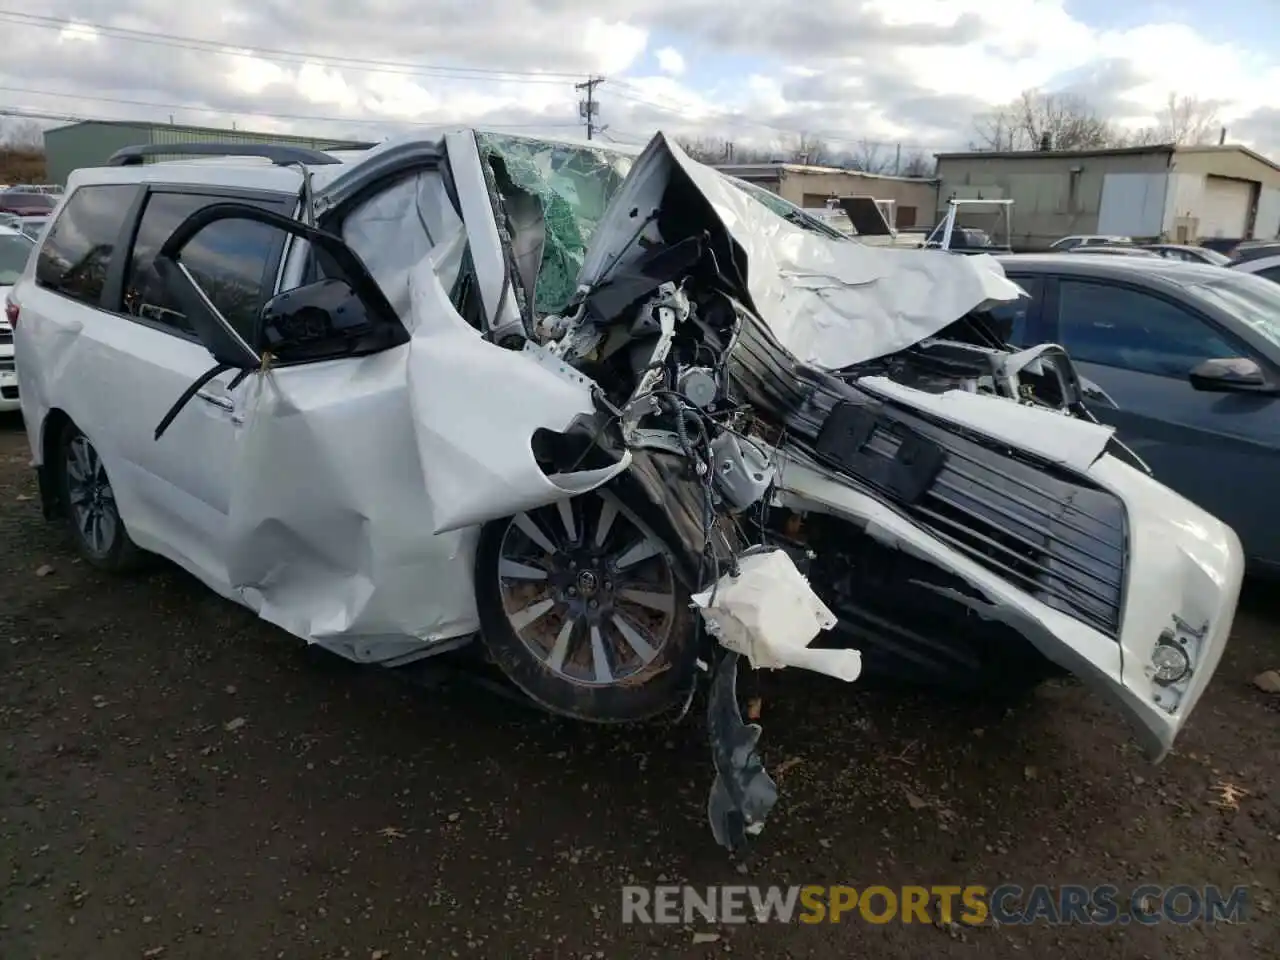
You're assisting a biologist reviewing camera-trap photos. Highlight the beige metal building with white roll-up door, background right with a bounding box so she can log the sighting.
[937,145,1280,250]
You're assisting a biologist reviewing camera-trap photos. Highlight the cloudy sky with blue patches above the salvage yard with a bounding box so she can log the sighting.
[0,0,1280,155]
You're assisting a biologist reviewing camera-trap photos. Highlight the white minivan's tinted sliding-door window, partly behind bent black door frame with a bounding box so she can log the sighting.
[124,192,294,339]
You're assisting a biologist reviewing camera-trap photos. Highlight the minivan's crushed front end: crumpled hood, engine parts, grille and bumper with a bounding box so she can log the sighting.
[448,136,1242,849]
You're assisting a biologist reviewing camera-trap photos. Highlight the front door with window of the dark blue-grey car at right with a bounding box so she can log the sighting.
[1043,278,1280,563]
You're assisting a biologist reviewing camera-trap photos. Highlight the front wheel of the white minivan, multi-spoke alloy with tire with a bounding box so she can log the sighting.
[476,490,698,722]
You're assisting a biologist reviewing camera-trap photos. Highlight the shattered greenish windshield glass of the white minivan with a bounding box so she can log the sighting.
[476,133,631,315]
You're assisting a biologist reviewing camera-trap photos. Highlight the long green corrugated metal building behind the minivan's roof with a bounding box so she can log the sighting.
[45,120,369,183]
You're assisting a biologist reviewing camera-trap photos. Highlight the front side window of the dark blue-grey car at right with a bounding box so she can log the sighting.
[1057,280,1240,378]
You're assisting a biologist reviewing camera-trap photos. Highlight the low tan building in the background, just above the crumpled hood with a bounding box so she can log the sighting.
[716,163,938,228]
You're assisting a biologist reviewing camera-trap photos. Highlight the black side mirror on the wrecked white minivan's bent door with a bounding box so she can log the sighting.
[255,279,375,360]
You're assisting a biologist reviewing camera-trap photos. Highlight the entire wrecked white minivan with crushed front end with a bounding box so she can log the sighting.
[8,131,1242,847]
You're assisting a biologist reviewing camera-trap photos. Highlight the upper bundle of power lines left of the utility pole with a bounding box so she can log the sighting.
[0,9,582,84]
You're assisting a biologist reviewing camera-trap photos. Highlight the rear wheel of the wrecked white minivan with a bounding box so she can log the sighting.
[58,421,143,573]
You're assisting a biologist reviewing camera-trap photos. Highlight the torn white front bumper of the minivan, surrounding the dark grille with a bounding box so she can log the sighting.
[780,449,1244,762]
